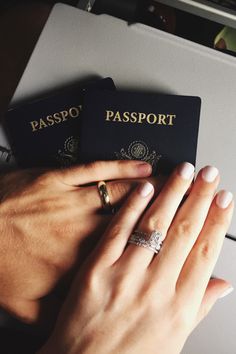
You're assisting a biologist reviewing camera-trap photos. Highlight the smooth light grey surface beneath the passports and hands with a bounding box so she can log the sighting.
[8,5,236,354]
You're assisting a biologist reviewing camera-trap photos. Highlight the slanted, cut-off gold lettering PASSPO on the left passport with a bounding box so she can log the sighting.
[30,105,82,132]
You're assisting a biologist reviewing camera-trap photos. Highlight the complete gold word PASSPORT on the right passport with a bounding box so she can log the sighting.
[105,110,176,126]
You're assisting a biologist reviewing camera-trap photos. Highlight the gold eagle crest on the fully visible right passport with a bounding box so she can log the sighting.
[115,140,162,172]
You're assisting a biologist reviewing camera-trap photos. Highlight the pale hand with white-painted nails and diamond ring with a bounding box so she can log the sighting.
[40,163,233,354]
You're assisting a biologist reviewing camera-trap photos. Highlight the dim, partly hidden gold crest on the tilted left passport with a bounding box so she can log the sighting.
[57,136,79,166]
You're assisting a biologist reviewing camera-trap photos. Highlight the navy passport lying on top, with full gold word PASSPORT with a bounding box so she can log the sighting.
[80,91,201,175]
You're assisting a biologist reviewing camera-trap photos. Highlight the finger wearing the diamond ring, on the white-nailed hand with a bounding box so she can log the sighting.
[122,162,194,267]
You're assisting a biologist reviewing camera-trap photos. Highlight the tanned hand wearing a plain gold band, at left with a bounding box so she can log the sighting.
[0,161,151,323]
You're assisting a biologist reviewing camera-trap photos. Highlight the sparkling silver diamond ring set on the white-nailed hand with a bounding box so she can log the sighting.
[128,230,163,253]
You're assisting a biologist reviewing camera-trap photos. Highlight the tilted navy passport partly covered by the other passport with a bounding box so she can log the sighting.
[5,78,115,167]
